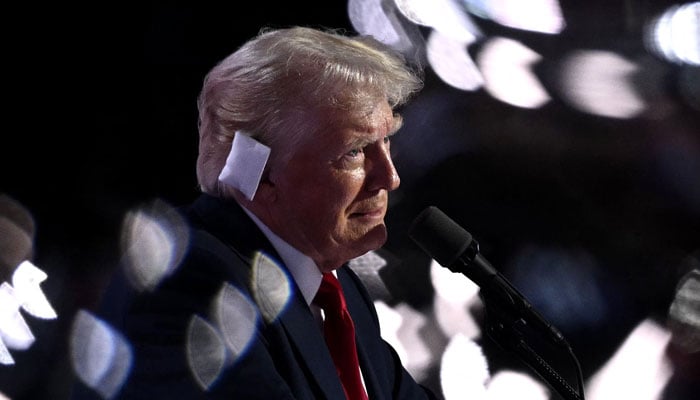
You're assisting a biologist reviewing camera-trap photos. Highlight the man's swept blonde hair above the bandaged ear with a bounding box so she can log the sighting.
[197,27,423,195]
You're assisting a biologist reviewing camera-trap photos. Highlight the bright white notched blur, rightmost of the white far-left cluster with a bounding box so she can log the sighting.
[12,261,57,319]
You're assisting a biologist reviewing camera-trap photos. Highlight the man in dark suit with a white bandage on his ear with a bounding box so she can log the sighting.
[87,27,434,400]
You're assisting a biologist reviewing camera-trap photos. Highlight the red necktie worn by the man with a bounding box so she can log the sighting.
[314,273,367,400]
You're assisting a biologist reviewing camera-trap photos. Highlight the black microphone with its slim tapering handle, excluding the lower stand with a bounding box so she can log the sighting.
[408,206,568,346]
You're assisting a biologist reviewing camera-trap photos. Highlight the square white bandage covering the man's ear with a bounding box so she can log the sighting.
[219,131,270,200]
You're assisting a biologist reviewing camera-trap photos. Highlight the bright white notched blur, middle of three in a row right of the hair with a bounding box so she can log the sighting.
[477,37,550,108]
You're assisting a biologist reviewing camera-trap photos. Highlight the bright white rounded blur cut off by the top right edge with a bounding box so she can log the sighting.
[645,2,700,65]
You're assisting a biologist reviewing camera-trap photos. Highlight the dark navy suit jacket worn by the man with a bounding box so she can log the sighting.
[79,195,435,400]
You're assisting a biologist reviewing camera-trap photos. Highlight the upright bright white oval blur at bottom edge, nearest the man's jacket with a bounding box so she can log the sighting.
[440,334,486,400]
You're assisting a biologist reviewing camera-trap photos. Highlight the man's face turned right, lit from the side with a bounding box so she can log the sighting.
[269,101,400,271]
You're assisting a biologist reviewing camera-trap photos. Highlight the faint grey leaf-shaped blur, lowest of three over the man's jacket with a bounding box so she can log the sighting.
[187,315,226,390]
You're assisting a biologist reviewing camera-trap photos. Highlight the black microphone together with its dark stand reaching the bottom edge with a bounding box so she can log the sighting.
[409,207,584,400]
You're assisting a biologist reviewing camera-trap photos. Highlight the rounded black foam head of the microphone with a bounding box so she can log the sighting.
[408,206,472,269]
